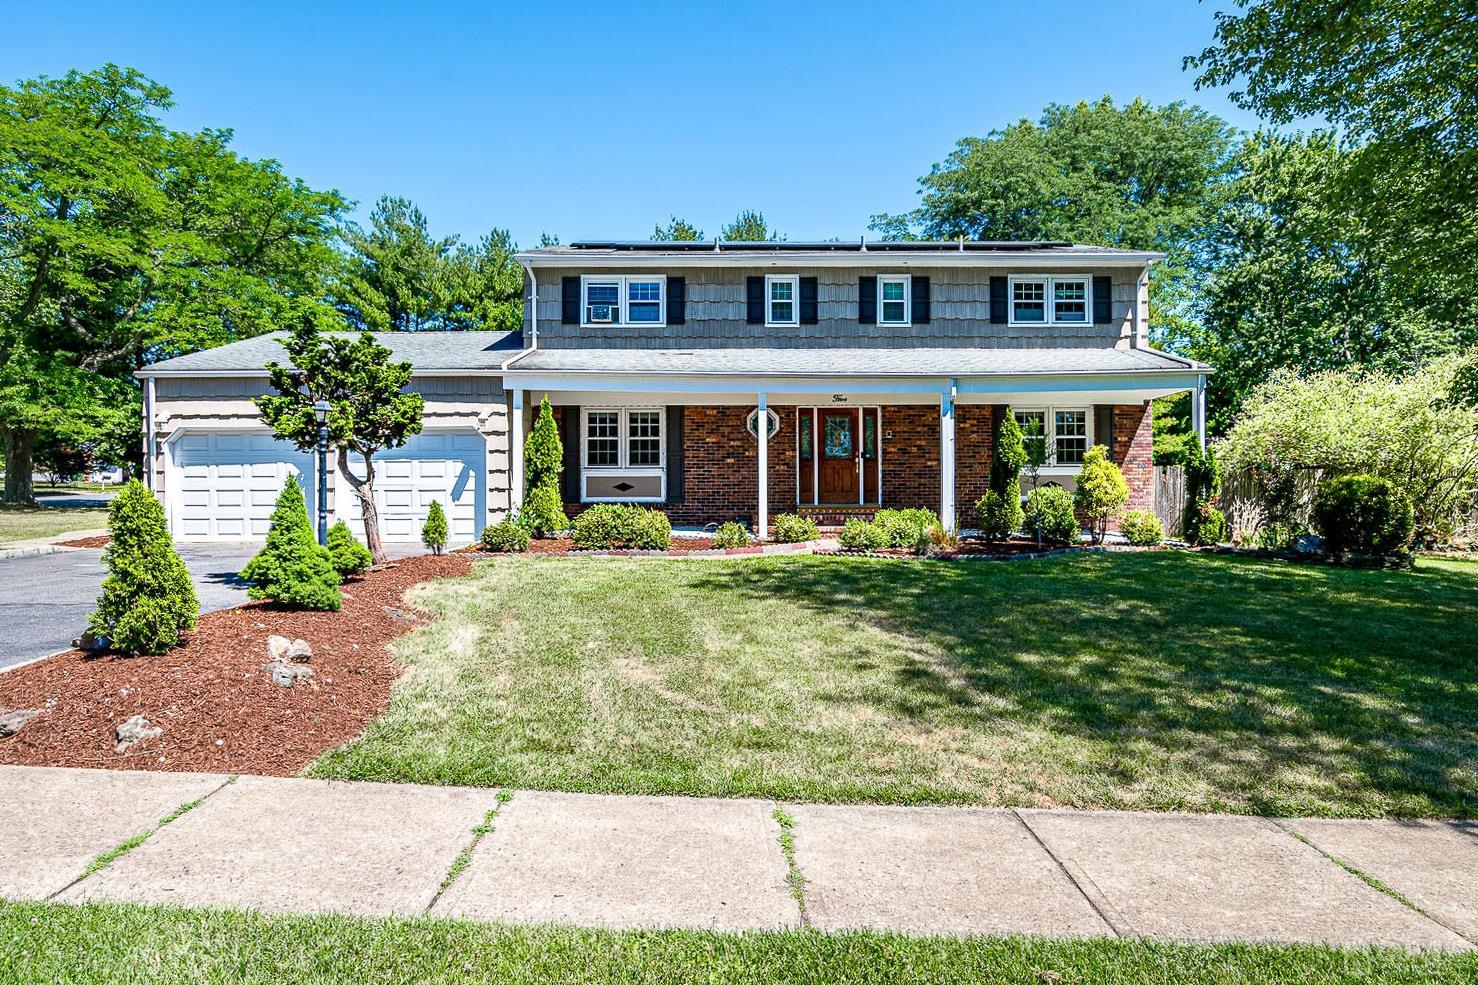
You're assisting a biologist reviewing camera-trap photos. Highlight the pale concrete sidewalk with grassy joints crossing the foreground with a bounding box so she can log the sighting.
[0,766,1478,950]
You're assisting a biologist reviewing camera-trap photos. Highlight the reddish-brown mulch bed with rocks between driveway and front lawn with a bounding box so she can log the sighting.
[0,555,471,776]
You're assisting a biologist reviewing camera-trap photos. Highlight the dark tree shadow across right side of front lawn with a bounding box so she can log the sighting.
[696,553,1478,816]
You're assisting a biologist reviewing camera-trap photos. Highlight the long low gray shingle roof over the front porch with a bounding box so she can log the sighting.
[507,346,1210,379]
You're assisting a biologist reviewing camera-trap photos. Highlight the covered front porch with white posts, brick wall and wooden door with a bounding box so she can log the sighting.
[507,351,1205,535]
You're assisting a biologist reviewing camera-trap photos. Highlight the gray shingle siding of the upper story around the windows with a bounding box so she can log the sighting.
[525,265,1142,349]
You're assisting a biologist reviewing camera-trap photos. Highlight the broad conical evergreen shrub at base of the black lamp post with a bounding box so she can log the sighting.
[241,478,343,612]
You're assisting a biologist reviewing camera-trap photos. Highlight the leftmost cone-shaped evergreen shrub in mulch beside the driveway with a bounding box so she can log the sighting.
[87,479,200,654]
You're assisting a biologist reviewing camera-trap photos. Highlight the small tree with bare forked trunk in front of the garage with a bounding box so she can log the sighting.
[257,309,426,563]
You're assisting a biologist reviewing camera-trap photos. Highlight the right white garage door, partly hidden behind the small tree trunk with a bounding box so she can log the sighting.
[336,430,488,544]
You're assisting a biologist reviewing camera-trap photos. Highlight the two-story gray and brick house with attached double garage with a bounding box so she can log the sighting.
[140,241,1209,541]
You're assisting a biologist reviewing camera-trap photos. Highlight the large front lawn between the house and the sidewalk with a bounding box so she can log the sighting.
[310,552,1478,816]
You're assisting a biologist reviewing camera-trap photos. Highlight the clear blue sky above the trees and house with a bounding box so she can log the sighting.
[0,0,1256,244]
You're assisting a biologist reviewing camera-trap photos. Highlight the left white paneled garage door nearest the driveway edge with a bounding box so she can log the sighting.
[171,432,313,540]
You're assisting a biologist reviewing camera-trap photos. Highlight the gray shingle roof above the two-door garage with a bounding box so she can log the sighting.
[143,331,523,376]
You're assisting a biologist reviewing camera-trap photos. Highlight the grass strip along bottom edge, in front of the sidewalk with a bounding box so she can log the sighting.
[0,902,1478,985]
